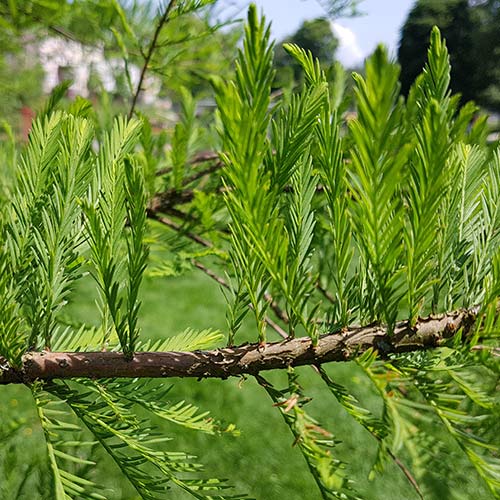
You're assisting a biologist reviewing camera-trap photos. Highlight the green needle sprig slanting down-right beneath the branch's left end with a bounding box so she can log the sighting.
[50,380,247,500]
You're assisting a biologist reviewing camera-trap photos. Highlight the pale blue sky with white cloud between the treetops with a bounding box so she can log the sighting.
[221,0,415,66]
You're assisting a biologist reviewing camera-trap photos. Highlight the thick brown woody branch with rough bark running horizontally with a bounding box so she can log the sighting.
[0,310,476,384]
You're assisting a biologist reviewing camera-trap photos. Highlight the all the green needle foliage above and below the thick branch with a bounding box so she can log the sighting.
[0,0,500,500]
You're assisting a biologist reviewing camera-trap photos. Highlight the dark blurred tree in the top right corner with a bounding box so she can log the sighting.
[398,0,500,111]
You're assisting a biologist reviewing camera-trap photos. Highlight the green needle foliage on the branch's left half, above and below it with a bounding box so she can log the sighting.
[0,105,240,499]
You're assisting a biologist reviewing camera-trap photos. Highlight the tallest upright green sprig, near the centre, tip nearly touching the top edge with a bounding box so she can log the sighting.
[215,5,276,342]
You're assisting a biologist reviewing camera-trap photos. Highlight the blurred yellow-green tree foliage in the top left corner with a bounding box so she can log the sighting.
[0,0,131,128]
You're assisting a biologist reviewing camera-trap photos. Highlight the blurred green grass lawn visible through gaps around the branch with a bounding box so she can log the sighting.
[0,273,489,500]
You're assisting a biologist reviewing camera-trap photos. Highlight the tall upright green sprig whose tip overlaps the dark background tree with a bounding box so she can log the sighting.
[404,28,451,324]
